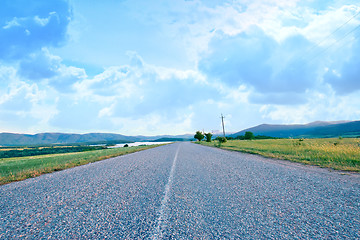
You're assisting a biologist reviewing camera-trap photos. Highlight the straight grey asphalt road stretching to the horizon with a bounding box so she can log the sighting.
[0,143,360,239]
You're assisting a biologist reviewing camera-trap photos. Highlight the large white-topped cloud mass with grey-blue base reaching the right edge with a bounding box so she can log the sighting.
[198,1,359,105]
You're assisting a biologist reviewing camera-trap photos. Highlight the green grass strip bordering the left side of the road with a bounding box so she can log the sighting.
[0,145,159,185]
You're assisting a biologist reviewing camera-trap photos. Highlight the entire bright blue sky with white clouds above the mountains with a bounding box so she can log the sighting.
[0,0,360,135]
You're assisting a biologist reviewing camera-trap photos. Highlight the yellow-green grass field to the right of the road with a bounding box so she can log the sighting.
[201,138,360,172]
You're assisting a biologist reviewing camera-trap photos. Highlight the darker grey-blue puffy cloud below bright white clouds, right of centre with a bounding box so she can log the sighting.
[199,28,318,104]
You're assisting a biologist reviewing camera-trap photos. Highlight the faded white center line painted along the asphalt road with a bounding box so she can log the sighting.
[151,145,180,239]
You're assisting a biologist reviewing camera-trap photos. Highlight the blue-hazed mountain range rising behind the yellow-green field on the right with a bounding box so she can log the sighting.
[231,121,360,138]
